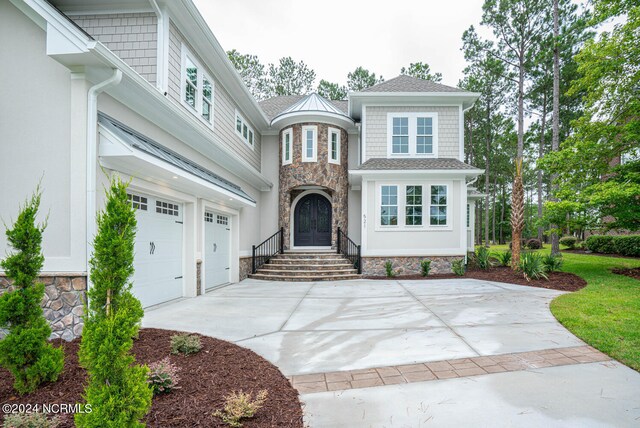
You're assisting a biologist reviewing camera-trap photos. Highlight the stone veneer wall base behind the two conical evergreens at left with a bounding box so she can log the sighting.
[0,274,87,341]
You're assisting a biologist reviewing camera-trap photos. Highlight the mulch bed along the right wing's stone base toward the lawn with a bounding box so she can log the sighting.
[365,266,587,291]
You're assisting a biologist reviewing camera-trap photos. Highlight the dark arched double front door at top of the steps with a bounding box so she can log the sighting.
[293,193,331,247]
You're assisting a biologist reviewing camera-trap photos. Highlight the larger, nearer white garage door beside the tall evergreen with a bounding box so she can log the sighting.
[129,194,182,308]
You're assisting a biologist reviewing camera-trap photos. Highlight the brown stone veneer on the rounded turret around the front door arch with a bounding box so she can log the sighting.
[278,123,349,249]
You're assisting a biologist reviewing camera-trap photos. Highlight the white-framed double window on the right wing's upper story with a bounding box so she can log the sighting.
[387,113,438,157]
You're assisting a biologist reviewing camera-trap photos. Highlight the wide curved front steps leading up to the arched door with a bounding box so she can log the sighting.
[249,251,362,282]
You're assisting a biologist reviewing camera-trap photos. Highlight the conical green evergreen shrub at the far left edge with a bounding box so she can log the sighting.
[0,188,64,394]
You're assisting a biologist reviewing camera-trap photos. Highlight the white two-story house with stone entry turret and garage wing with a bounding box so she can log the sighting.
[0,0,482,338]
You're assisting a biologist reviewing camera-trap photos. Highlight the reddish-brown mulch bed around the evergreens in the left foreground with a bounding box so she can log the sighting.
[0,329,303,428]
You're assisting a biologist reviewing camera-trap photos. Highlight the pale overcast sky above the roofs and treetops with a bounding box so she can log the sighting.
[194,0,488,86]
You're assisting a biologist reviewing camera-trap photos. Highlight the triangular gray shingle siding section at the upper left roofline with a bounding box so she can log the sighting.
[69,13,158,84]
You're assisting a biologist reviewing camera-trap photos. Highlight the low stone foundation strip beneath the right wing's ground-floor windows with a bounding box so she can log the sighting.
[362,256,463,276]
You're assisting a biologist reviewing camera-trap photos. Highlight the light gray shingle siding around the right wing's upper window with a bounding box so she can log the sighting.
[364,106,460,159]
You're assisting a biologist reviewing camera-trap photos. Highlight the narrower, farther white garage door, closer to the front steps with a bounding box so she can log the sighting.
[204,212,231,288]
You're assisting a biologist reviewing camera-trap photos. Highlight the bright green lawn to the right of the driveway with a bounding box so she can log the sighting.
[482,245,640,371]
